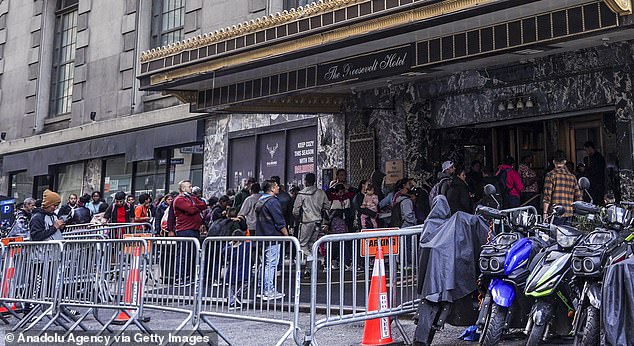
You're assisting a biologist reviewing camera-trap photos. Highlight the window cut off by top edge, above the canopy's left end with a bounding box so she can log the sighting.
[152,0,185,47]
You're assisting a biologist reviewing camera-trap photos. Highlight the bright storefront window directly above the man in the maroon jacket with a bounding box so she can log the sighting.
[169,144,203,191]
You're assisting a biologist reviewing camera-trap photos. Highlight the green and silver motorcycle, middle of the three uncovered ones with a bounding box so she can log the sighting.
[524,178,599,346]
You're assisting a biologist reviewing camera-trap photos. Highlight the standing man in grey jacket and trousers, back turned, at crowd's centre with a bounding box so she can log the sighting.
[293,173,330,274]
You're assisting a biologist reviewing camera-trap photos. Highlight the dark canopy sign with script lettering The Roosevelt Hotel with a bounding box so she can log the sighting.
[317,45,415,85]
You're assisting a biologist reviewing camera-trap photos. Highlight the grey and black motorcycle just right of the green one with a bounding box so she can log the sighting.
[572,201,634,345]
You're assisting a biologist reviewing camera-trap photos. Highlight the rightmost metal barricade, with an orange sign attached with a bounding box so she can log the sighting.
[304,226,421,344]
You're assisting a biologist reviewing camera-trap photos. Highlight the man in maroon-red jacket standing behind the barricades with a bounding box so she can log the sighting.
[168,180,207,286]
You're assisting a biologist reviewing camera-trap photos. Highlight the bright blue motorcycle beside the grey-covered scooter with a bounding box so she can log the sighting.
[477,207,549,345]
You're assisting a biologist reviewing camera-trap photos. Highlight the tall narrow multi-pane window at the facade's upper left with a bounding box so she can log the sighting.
[50,0,78,116]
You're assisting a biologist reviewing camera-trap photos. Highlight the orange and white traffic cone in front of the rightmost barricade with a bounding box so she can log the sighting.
[361,246,394,346]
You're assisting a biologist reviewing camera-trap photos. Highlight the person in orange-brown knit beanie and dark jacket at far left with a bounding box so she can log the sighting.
[29,189,65,241]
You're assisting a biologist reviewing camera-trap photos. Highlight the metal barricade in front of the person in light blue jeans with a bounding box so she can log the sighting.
[194,237,302,345]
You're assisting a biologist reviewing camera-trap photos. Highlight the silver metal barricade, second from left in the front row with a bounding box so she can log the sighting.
[34,238,149,335]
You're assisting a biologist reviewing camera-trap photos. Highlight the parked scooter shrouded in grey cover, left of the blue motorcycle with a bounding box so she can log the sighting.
[414,195,488,345]
